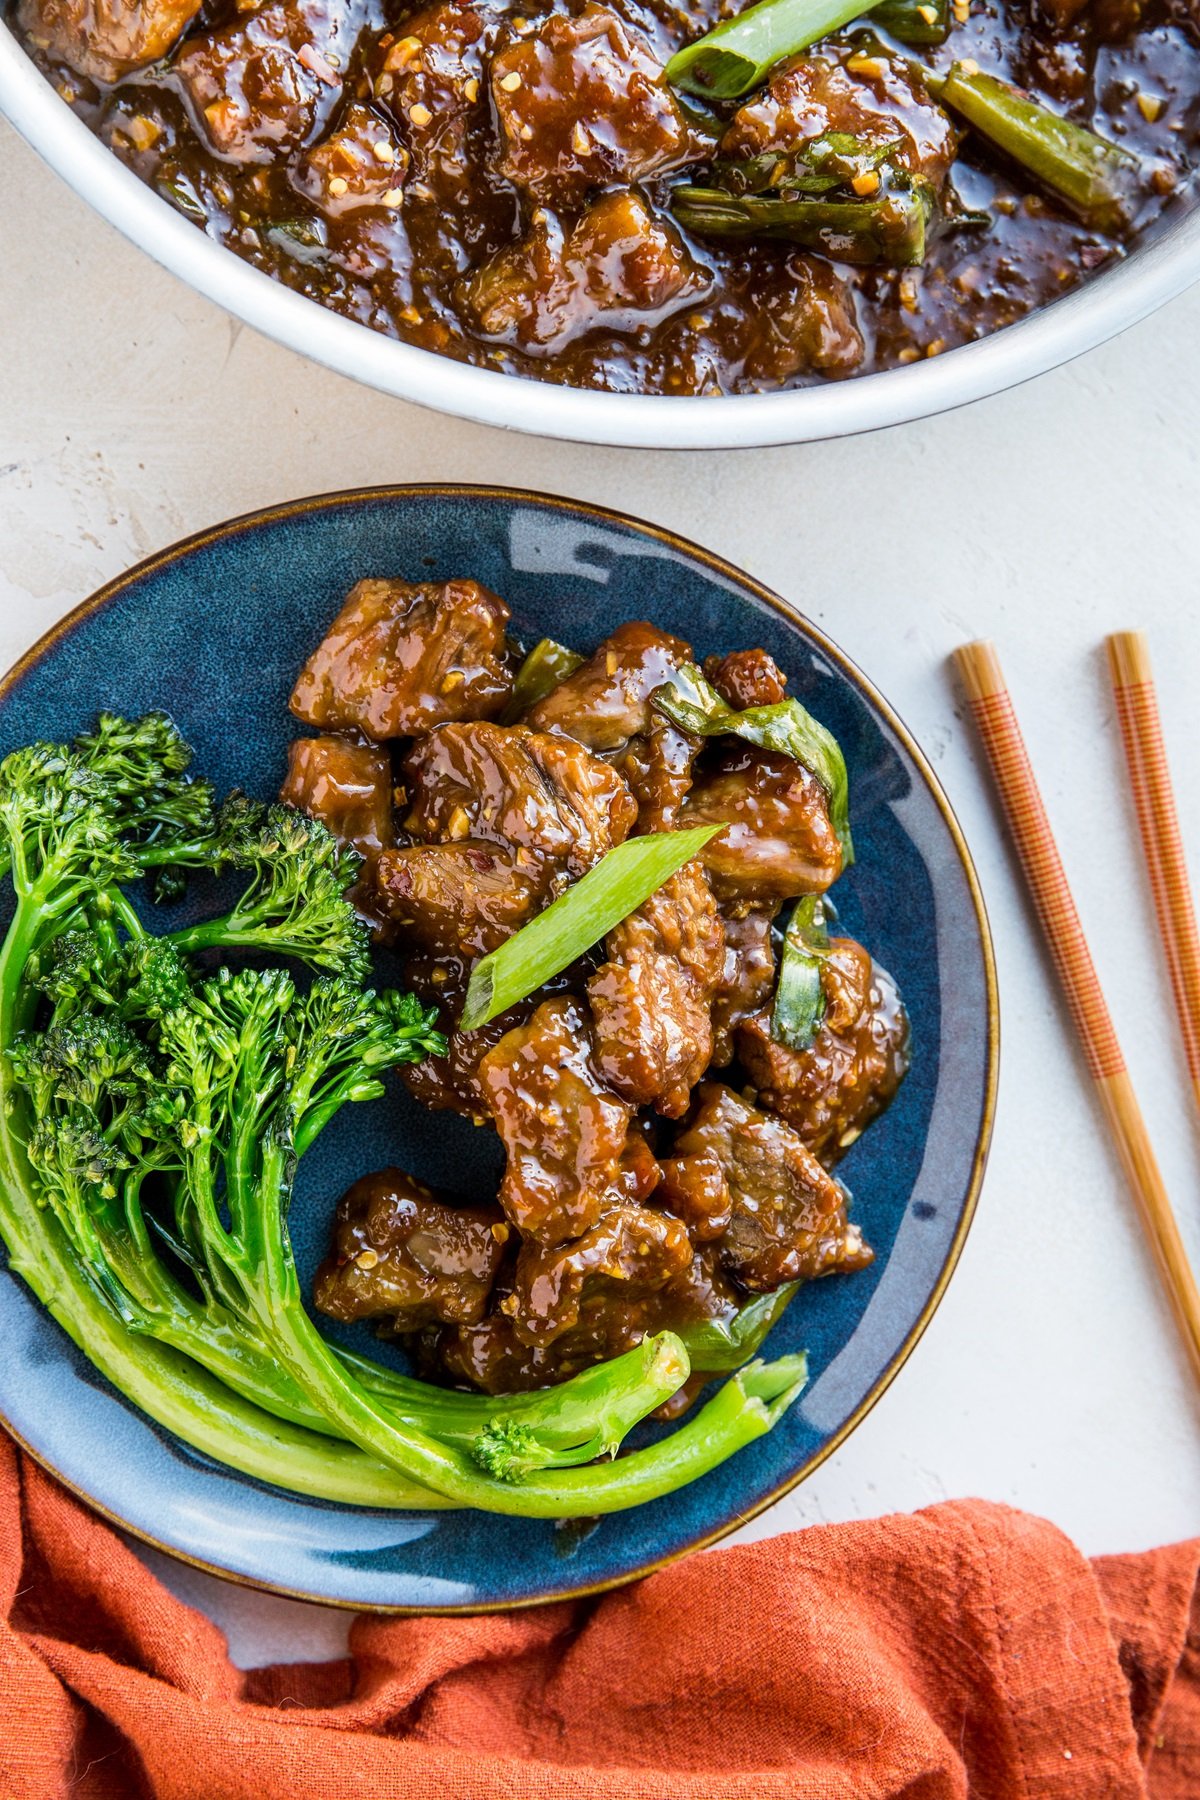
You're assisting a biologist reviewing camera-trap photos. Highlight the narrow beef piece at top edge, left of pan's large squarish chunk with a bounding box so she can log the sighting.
[369,0,495,205]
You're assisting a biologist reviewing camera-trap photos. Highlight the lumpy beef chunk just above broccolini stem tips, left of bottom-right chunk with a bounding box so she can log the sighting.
[506,1206,693,1345]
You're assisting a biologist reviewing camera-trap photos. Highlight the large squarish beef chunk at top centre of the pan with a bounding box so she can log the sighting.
[491,5,703,207]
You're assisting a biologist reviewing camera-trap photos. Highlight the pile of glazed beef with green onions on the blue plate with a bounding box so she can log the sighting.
[282,581,909,1411]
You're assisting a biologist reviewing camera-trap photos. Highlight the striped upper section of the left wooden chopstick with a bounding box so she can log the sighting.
[959,644,1124,1082]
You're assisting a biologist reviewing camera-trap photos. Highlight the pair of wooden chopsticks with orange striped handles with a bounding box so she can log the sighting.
[957,632,1200,1381]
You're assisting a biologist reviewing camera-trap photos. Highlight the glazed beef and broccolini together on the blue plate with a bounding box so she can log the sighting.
[0,581,907,1517]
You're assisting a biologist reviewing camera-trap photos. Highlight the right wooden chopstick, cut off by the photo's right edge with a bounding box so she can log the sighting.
[1108,632,1200,1105]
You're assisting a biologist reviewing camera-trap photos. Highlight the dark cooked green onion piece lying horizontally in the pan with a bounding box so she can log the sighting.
[671,185,928,268]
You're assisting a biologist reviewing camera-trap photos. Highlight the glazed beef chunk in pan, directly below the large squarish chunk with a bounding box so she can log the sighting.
[462,193,712,355]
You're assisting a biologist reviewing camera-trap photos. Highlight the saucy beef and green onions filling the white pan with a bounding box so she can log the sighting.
[16,0,1200,394]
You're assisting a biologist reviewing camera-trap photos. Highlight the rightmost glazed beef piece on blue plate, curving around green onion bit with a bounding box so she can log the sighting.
[736,938,909,1163]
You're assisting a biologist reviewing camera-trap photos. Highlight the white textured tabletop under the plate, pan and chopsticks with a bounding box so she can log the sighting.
[0,124,1200,1663]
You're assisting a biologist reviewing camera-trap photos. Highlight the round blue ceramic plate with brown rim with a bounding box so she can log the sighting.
[0,488,997,1611]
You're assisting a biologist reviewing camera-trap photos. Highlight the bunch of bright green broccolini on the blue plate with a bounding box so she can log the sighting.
[0,715,797,1517]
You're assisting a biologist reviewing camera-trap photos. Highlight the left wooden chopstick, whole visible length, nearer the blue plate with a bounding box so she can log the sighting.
[957,643,1200,1381]
